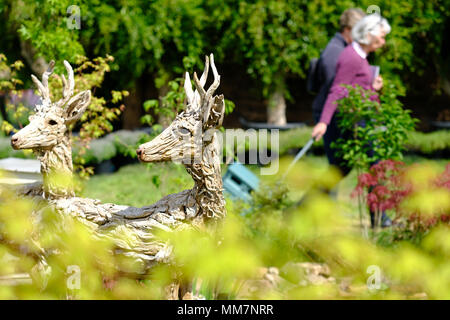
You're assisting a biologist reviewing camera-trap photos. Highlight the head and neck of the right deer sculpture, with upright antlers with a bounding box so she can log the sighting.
[136,54,225,218]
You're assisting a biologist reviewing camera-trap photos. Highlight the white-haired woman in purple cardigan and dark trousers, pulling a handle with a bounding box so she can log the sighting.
[312,14,391,228]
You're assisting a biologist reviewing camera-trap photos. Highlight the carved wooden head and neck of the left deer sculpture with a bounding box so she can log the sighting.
[11,61,91,198]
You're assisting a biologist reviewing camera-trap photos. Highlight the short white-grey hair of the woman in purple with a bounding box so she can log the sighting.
[352,13,391,44]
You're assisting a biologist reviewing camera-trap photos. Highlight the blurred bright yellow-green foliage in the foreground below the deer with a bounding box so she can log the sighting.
[0,162,450,299]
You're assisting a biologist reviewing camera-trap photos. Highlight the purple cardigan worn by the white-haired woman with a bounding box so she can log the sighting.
[320,45,373,125]
